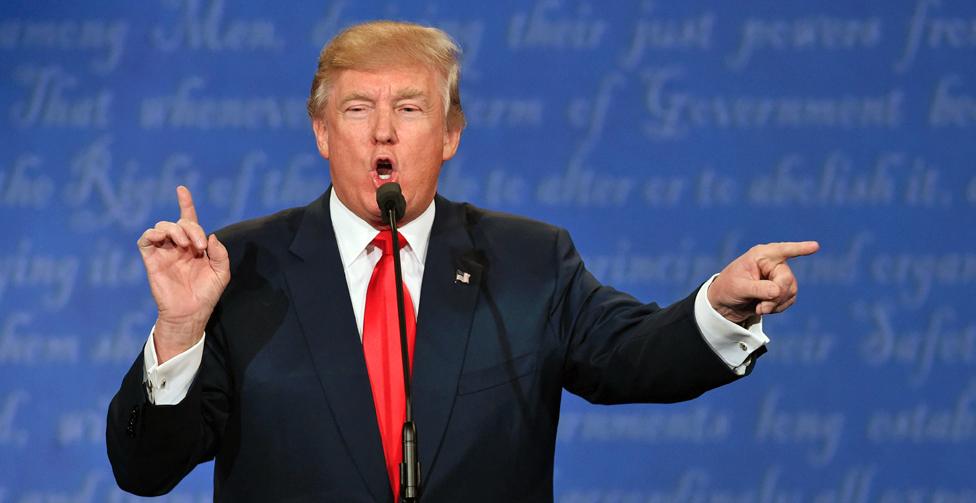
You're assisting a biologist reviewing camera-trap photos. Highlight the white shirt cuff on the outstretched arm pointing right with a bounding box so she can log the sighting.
[695,274,769,375]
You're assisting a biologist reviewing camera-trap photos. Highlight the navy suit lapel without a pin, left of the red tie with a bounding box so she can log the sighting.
[286,191,388,501]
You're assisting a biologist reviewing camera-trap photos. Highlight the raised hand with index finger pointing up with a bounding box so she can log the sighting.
[138,185,230,364]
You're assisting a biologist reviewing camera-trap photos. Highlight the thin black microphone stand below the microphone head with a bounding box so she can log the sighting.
[386,207,420,503]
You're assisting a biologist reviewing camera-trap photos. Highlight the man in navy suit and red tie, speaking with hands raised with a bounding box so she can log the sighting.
[107,22,817,502]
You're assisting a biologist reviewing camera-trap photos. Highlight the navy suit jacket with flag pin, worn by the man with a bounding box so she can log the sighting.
[107,192,756,503]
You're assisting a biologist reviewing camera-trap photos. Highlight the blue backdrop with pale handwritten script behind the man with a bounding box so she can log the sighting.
[0,0,976,503]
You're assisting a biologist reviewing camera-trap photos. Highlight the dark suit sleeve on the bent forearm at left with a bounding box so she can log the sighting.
[106,312,231,496]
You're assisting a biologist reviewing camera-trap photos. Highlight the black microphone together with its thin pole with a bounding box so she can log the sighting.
[376,182,420,503]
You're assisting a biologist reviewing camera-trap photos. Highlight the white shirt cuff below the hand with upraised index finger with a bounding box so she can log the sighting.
[142,326,207,405]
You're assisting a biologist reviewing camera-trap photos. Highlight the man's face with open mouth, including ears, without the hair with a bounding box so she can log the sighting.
[312,66,461,227]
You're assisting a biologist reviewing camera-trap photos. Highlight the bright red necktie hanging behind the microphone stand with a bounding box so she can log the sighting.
[363,229,417,501]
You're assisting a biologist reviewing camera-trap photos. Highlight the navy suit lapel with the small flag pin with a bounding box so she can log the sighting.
[412,196,484,481]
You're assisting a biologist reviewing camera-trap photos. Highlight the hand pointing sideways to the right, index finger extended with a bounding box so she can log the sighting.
[707,241,820,324]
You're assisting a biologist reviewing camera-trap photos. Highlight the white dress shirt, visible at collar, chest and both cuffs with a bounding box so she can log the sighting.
[143,191,769,405]
